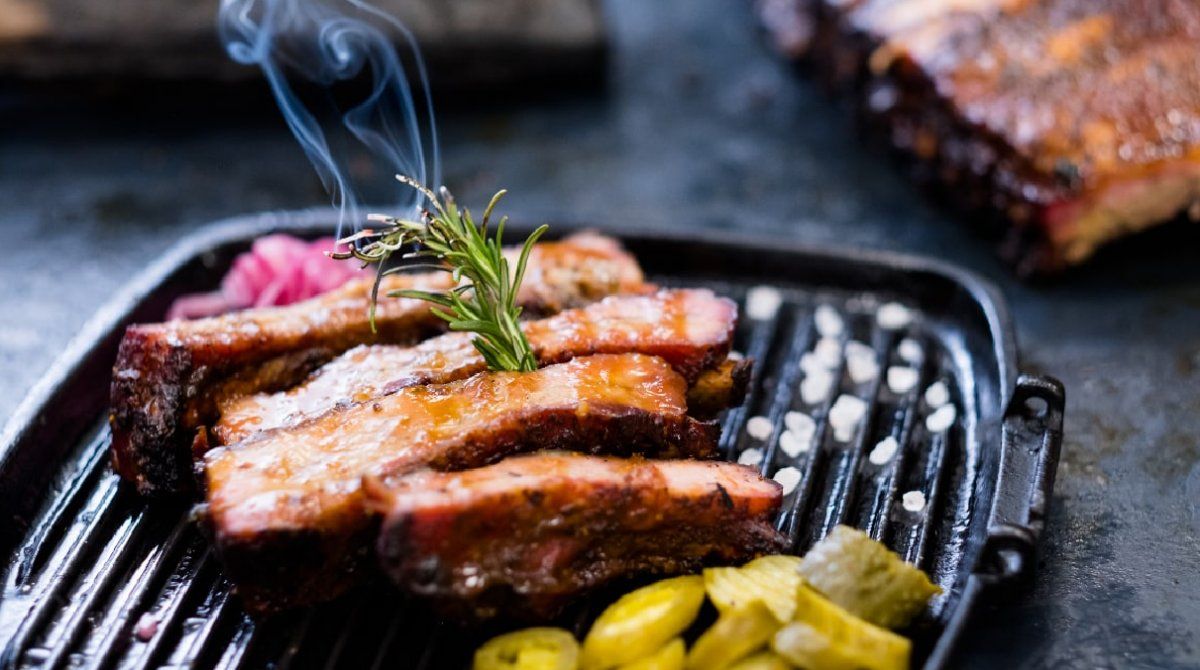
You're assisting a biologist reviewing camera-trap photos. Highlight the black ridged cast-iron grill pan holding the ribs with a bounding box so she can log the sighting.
[0,209,1064,669]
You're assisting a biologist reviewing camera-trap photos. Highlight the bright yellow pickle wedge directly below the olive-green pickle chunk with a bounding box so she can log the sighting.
[770,586,912,670]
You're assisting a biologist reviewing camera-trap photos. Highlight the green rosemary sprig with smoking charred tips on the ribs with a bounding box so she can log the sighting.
[330,175,546,372]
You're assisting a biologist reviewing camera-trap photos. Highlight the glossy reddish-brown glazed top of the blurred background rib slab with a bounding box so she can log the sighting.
[847,0,1200,194]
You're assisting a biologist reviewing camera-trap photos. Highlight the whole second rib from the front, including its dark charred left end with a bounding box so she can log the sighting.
[204,354,719,611]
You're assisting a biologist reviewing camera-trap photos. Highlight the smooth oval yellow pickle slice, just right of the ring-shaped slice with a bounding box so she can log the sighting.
[580,575,704,670]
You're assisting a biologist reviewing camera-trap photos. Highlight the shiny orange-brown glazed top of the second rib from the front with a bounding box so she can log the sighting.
[205,354,715,540]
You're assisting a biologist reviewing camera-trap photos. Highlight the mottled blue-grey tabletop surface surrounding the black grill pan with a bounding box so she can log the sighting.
[0,0,1200,668]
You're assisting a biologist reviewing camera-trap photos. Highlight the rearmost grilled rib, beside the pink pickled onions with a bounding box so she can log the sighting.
[110,234,650,493]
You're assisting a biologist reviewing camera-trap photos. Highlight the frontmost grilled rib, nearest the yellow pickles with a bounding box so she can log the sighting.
[366,454,787,618]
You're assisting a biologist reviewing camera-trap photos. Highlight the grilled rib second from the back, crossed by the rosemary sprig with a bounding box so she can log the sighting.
[212,289,737,444]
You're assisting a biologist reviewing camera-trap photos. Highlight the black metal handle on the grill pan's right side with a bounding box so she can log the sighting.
[974,373,1067,584]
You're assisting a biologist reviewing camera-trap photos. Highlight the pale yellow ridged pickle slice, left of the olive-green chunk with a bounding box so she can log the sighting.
[704,556,802,622]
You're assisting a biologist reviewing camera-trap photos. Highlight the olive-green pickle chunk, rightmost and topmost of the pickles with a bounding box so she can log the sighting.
[800,526,942,628]
